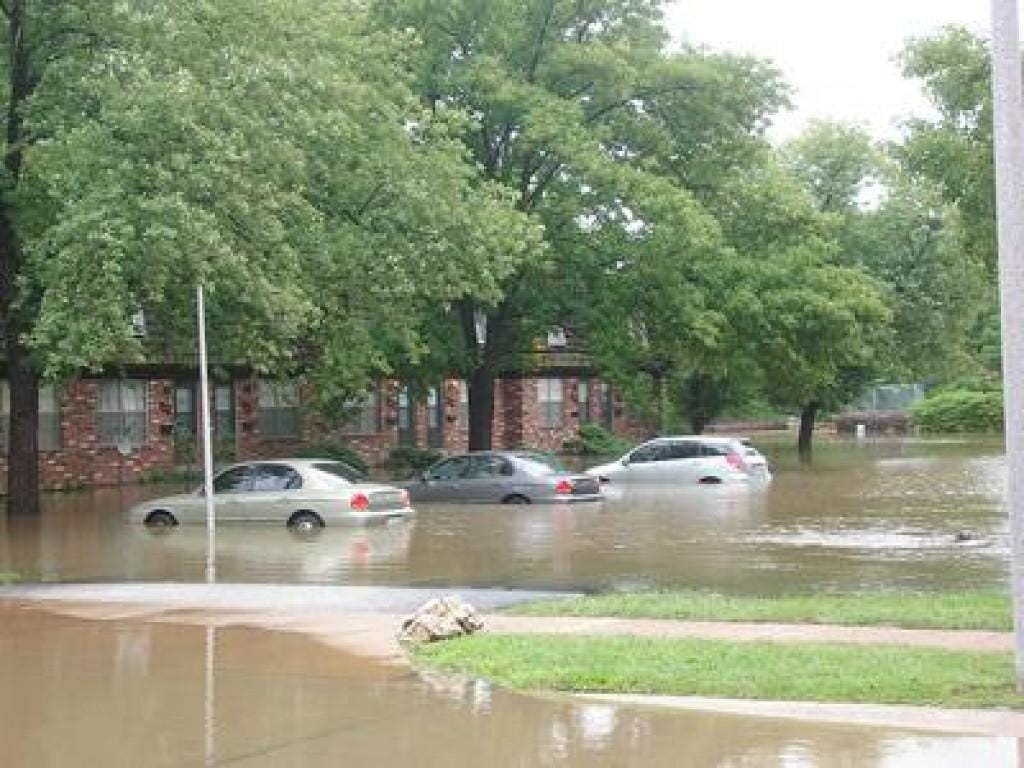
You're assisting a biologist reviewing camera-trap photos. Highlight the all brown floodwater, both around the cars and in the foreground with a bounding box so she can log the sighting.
[0,441,1024,768]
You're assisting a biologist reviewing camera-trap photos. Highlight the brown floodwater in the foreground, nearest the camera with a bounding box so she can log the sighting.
[0,609,1018,768]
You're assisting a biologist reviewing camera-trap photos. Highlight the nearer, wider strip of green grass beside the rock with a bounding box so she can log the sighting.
[414,635,1024,709]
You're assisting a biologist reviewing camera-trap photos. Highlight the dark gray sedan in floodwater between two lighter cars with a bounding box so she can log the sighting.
[407,451,602,504]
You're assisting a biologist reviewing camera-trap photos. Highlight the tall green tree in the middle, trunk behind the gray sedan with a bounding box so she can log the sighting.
[372,0,784,449]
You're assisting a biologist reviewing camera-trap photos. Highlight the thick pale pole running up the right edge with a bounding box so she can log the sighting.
[992,0,1024,691]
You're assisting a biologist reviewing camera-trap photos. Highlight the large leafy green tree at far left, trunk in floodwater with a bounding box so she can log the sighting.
[0,0,540,512]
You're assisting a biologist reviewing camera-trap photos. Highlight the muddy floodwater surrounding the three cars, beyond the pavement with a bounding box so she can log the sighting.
[0,441,1008,594]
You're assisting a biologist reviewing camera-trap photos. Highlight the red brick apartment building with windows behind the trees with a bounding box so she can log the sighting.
[0,333,644,489]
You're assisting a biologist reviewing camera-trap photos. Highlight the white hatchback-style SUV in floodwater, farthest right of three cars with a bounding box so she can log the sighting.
[587,436,771,484]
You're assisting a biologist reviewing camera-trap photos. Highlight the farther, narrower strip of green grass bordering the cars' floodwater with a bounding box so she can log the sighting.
[512,592,1013,631]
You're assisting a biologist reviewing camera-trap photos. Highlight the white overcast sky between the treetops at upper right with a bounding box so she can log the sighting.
[666,0,990,138]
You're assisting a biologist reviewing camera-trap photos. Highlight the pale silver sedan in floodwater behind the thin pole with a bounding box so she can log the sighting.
[128,459,413,530]
